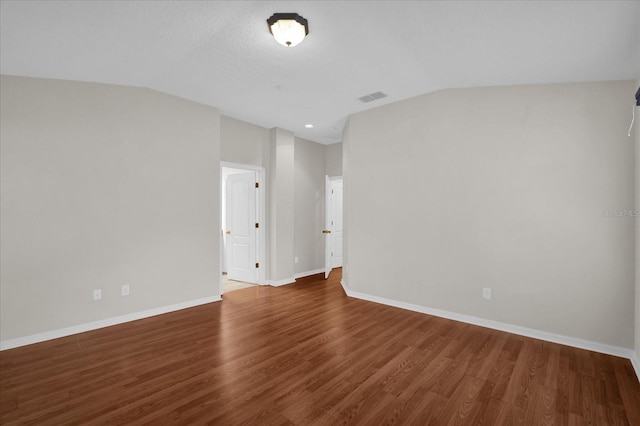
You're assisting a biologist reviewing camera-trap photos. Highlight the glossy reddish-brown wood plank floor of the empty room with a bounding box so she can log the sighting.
[0,271,640,425]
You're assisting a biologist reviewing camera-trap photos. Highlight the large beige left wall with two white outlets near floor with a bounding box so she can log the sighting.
[0,76,220,341]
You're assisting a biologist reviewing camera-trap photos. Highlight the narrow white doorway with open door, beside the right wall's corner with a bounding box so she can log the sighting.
[322,176,342,279]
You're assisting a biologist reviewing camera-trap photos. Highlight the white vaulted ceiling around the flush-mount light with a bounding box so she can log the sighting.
[0,0,640,144]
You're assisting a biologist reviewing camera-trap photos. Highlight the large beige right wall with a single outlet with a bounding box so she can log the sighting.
[343,81,635,348]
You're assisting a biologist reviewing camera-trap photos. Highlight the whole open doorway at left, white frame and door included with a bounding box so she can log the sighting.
[220,162,265,294]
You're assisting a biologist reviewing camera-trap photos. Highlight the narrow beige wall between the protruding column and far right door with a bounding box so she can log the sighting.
[294,138,326,274]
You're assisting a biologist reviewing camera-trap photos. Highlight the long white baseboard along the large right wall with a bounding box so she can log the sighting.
[341,288,638,362]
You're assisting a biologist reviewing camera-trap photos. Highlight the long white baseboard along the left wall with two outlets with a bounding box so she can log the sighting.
[0,296,222,351]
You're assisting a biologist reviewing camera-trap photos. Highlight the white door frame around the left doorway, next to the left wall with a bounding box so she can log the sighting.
[218,161,267,294]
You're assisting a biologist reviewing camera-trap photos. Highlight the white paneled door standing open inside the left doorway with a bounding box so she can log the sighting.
[225,172,256,283]
